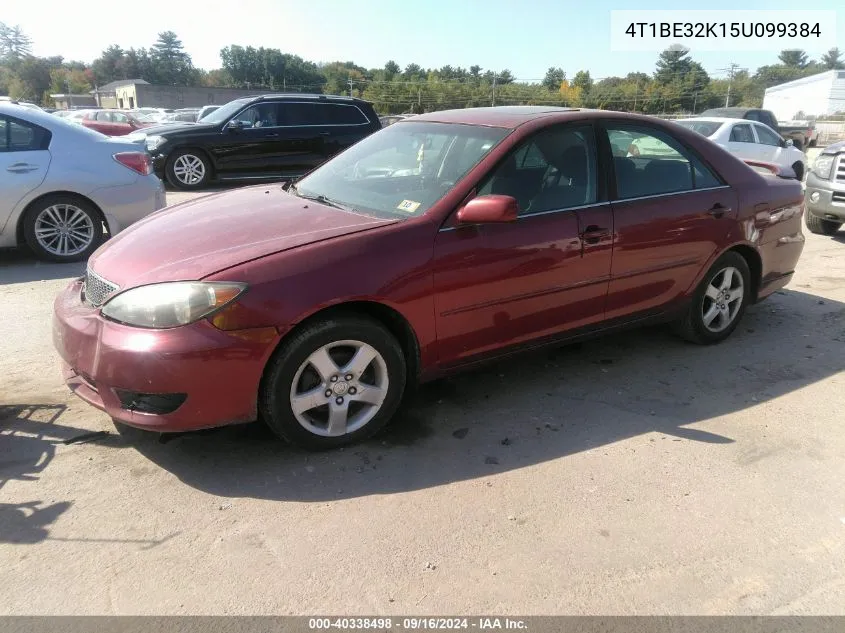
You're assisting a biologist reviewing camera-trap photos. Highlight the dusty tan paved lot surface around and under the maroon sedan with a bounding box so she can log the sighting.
[0,177,845,615]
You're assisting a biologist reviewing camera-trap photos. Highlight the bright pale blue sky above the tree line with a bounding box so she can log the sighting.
[0,0,845,80]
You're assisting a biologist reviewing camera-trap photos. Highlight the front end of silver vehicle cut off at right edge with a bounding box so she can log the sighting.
[805,141,845,235]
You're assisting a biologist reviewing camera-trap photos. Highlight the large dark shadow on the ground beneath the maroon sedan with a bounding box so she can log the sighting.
[109,290,845,501]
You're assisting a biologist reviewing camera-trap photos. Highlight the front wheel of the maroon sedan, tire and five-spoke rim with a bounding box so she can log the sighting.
[259,314,407,450]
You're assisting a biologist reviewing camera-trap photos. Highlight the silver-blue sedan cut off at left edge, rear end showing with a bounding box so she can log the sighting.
[0,103,165,262]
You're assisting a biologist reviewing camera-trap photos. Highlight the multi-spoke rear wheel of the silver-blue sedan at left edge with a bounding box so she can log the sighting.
[23,194,103,263]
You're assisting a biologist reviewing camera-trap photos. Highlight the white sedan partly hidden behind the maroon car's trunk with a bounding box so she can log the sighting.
[675,117,807,180]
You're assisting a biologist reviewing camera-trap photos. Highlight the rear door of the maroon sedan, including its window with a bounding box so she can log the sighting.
[605,123,737,319]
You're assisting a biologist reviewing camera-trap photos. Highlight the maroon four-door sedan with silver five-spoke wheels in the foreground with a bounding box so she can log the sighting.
[54,107,804,449]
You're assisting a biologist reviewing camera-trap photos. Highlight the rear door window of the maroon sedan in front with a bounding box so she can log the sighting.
[608,125,722,199]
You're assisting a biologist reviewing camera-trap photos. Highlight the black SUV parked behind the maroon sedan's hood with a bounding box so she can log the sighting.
[138,94,381,190]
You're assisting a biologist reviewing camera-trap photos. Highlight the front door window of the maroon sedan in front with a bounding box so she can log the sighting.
[478,126,598,215]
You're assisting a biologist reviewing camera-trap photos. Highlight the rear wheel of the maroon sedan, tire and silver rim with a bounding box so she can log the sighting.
[675,251,751,345]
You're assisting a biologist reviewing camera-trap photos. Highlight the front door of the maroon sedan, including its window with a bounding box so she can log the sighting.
[434,125,613,367]
